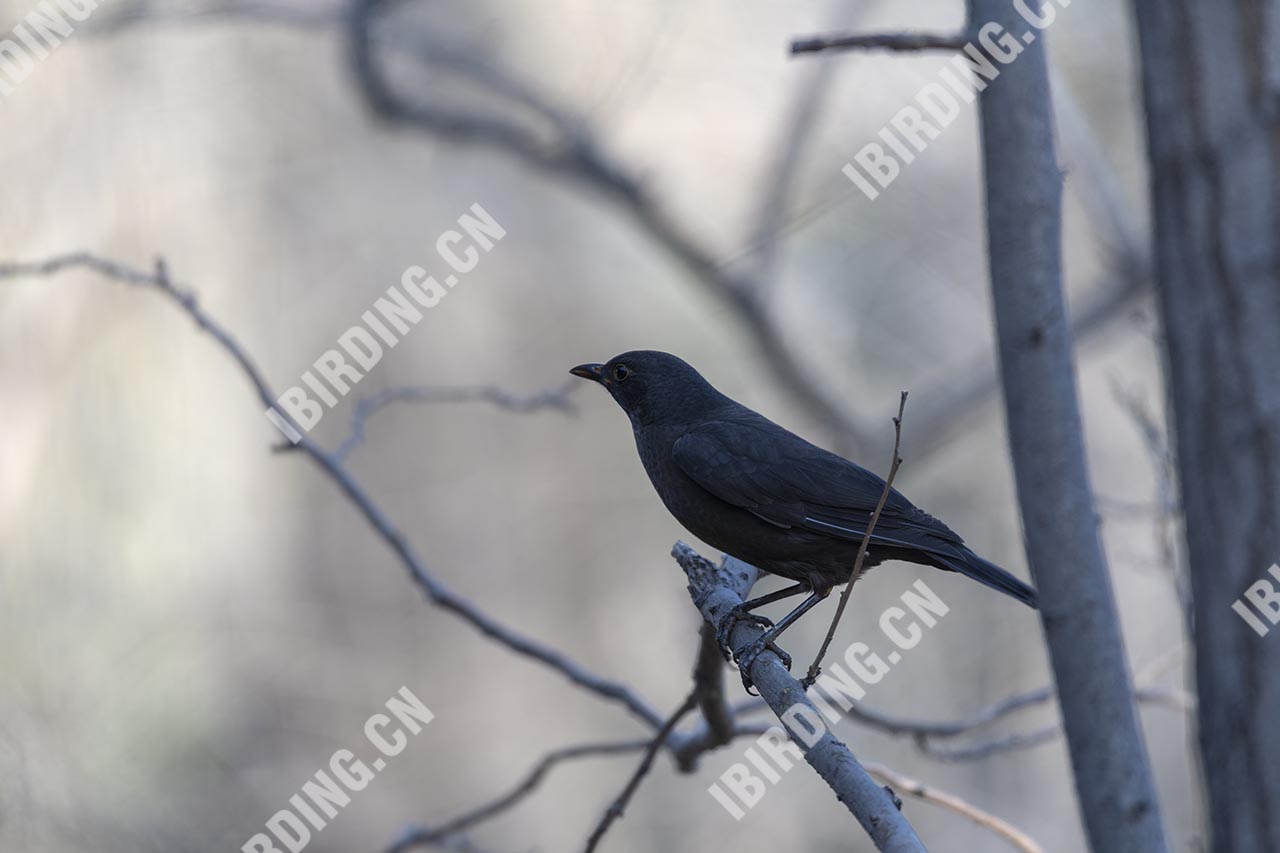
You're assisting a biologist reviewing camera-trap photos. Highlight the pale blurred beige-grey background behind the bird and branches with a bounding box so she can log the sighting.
[0,0,1201,853]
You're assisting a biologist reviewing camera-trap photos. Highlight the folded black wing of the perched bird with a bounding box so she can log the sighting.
[673,412,963,552]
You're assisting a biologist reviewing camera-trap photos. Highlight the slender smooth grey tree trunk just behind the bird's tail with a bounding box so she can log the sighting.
[969,0,1165,853]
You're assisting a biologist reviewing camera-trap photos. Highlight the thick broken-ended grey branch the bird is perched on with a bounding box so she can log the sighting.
[672,542,924,853]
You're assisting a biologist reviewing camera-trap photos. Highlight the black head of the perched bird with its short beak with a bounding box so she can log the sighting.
[570,350,727,424]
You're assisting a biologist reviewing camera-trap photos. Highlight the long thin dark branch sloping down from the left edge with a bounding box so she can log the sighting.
[0,252,663,729]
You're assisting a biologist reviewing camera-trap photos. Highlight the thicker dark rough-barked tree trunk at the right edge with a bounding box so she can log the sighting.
[1134,0,1280,853]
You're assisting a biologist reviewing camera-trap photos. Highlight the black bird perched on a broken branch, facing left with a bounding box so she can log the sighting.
[570,350,1037,680]
